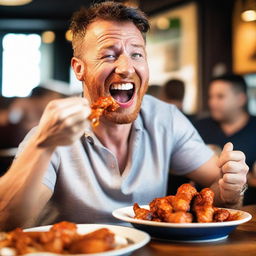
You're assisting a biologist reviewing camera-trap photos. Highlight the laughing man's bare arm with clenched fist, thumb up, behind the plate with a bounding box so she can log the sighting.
[187,143,249,208]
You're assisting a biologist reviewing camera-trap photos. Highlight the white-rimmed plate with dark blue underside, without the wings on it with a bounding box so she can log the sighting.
[112,205,252,242]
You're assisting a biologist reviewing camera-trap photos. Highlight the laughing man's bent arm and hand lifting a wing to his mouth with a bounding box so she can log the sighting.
[0,98,90,230]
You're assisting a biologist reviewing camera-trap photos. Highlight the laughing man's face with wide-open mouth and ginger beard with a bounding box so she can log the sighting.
[74,20,148,124]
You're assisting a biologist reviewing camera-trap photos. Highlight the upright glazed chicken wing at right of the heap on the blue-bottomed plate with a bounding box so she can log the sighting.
[193,188,214,222]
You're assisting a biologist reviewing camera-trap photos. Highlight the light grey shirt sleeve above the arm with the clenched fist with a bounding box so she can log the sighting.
[171,108,213,175]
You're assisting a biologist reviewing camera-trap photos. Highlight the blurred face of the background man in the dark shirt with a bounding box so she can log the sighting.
[208,80,245,122]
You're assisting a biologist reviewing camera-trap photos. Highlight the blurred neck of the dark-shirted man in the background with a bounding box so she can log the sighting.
[220,111,249,136]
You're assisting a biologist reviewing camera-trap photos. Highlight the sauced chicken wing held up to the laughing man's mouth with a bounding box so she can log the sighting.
[88,96,119,127]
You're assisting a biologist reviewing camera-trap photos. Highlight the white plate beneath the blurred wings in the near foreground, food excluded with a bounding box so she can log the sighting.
[22,224,150,256]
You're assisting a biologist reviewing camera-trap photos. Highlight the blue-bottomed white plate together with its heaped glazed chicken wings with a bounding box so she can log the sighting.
[112,184,252,242]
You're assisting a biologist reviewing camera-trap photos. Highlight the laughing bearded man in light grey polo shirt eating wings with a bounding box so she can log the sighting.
[0,2,247,229]
